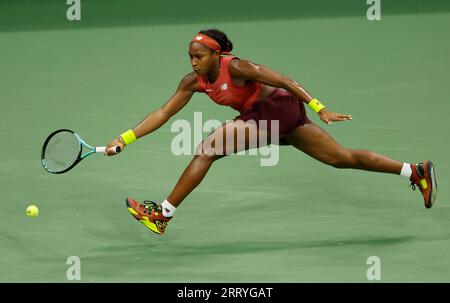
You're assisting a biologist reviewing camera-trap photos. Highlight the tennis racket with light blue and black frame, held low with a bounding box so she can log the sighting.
[41,129,121,174]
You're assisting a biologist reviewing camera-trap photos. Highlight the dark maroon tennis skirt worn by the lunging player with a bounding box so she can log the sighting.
[235,88,311,137]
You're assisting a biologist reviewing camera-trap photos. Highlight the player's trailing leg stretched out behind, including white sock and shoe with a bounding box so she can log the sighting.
[286,123,437,208]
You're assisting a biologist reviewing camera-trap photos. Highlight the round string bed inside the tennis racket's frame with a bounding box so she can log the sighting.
[43,132,81,172]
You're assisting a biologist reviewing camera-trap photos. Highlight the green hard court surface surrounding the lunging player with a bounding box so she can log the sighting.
[0,0,450,283]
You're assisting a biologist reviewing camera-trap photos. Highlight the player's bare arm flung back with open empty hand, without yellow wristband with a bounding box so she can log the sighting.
[229,59,352,124]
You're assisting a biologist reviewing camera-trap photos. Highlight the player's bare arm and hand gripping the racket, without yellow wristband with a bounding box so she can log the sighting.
[105,72,198,156]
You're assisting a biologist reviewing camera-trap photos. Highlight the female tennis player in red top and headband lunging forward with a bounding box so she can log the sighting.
[105,29,437,234]
